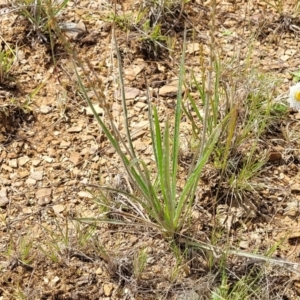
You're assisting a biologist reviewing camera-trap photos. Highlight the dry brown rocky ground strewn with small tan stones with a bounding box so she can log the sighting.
[0,0,300,299]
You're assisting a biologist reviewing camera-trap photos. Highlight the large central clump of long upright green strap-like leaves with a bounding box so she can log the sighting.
[73,28,221,238]
